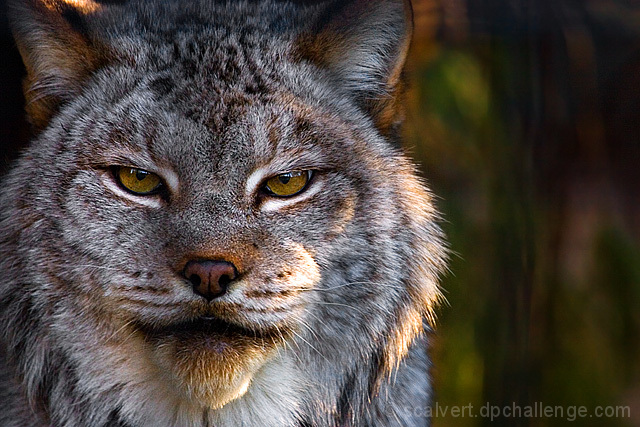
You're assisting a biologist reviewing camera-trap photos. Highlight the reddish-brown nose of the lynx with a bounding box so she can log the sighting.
[183,260,238,301]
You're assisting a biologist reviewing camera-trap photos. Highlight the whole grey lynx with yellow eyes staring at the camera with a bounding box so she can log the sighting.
[0,0,446,427]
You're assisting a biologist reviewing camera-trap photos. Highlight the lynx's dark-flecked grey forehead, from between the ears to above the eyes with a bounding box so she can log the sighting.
[77,1,360,170]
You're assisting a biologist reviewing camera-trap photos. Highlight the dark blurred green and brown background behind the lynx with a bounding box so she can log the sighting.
[0,0,640,427]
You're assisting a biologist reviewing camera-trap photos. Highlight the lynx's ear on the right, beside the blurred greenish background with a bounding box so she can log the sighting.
[300,0,413,134]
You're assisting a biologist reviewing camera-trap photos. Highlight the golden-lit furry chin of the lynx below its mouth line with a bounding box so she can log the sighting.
[141,317,288,410]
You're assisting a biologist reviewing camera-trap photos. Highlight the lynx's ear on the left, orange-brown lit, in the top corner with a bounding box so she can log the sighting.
[9,0,102,130]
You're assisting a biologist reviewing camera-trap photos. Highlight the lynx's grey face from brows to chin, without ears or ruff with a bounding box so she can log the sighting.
[52,92,370,408]
